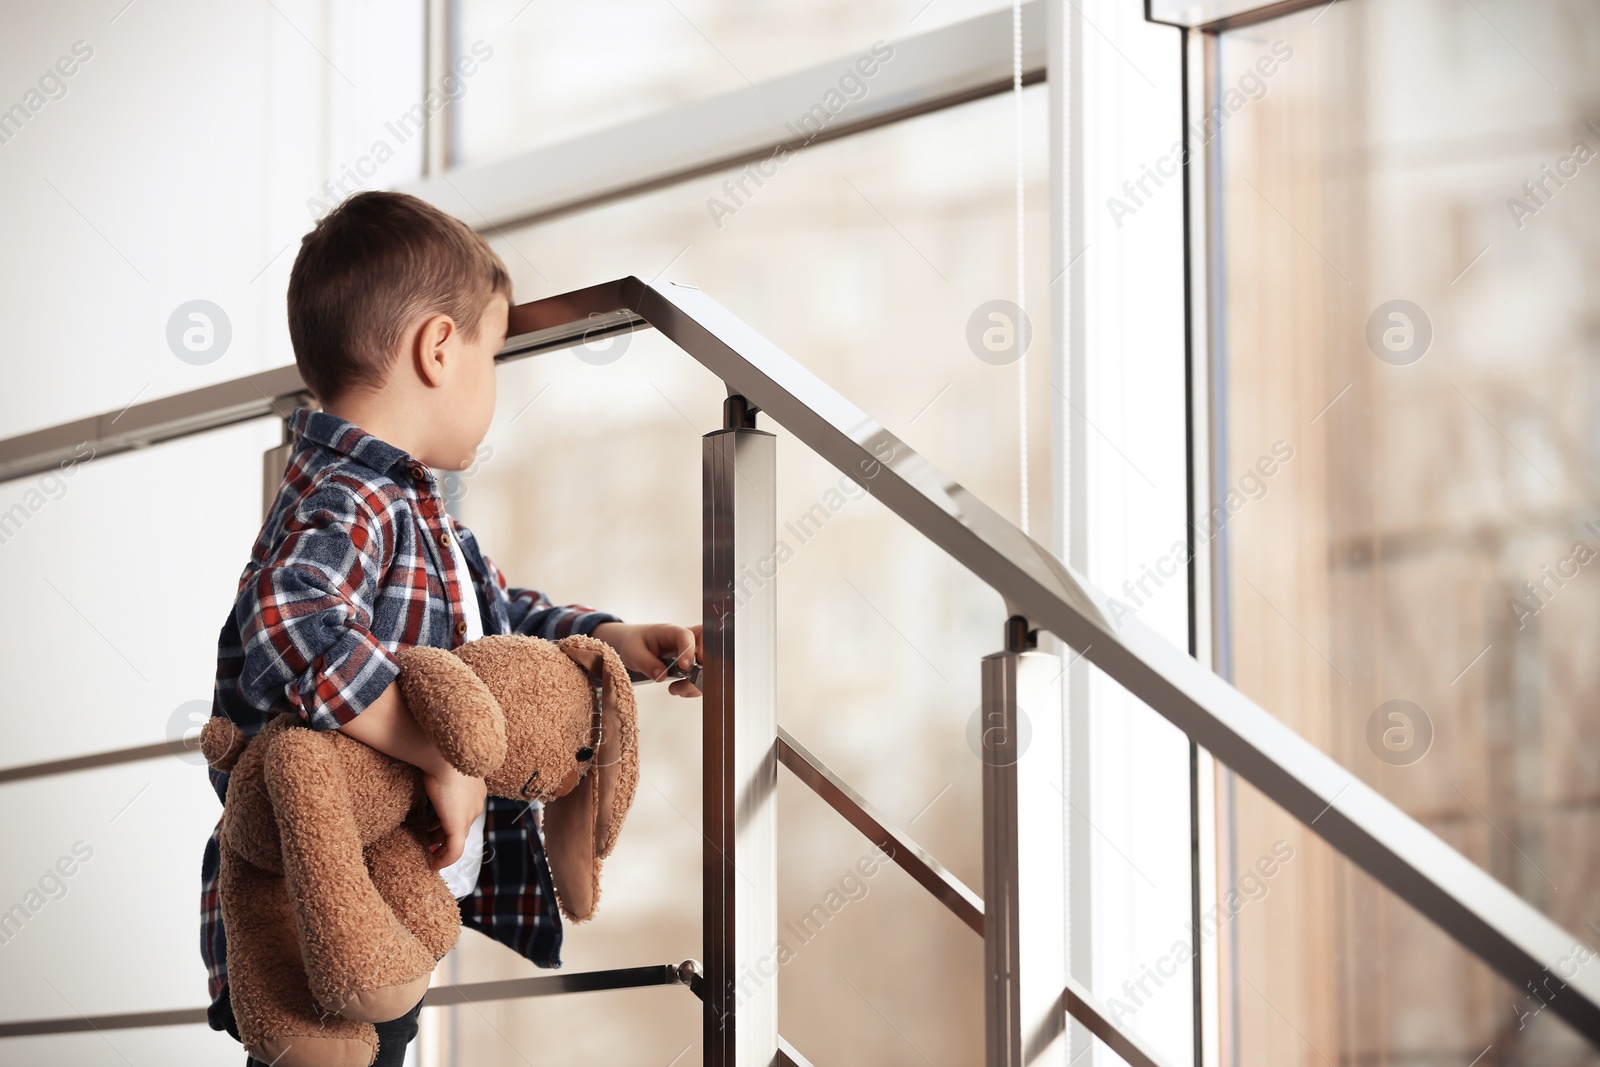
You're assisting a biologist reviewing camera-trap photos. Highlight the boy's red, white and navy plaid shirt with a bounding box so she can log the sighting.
[200,408,619,1030]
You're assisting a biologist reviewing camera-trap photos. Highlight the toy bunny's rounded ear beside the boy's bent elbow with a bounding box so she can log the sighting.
[398,645,506,777]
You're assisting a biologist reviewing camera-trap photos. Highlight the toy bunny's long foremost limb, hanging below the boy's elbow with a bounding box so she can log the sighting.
[264,729,435,1022]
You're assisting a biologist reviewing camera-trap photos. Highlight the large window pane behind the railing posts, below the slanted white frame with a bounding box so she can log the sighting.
[444,86,1050,1067]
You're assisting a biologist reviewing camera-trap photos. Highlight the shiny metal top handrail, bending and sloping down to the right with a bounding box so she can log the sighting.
[0,277,1600,1045]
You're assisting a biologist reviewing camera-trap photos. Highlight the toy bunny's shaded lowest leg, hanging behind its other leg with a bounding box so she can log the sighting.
[218,848,380,1067]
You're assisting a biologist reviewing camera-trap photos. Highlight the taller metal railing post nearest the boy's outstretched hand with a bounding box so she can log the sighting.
[701,395,778,1067]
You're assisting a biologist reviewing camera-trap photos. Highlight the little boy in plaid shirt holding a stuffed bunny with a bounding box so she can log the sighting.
[200,192,701,1065]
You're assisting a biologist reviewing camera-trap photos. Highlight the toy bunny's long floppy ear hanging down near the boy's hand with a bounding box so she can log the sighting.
[544,633,638,923]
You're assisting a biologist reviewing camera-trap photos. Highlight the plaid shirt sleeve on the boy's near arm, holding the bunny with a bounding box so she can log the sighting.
[234,483,400,729]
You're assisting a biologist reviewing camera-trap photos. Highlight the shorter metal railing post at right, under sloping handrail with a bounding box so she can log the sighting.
[978,616,1070,1067]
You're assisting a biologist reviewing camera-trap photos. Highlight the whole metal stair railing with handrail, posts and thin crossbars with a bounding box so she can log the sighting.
[0,277,1600,1067]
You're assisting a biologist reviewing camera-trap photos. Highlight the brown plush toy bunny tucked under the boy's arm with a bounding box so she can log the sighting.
[202,635,638,1067]
